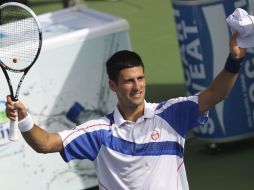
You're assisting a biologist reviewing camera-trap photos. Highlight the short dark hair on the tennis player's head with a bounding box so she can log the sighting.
[106,50,144,82]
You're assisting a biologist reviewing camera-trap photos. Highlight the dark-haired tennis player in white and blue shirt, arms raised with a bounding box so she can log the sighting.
[6,31,246,190]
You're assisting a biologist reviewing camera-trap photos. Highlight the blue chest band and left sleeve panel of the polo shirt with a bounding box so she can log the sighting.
[60,130,183,162]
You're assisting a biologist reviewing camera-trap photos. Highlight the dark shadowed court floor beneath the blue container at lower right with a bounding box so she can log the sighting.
[185,135,254,190]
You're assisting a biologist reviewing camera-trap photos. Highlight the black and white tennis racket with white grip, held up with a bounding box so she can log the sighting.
[0,2,42,141]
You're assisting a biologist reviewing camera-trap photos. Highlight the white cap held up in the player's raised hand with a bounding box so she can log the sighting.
[226,8,254,48]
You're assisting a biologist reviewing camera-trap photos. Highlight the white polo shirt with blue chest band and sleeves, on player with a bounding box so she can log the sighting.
[59,96,207,190]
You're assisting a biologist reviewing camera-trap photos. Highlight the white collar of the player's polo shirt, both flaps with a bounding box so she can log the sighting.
[114,100,155,126]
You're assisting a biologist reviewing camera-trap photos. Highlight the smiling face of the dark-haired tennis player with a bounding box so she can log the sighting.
[109,66,146,111]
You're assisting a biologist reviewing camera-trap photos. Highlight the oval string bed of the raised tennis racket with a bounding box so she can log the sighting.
[0,6,40,70]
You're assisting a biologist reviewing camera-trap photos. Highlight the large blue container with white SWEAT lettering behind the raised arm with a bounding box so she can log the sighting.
[173,0,254,142]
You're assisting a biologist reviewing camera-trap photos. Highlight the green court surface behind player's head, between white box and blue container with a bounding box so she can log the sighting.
[5,0,185,101]
